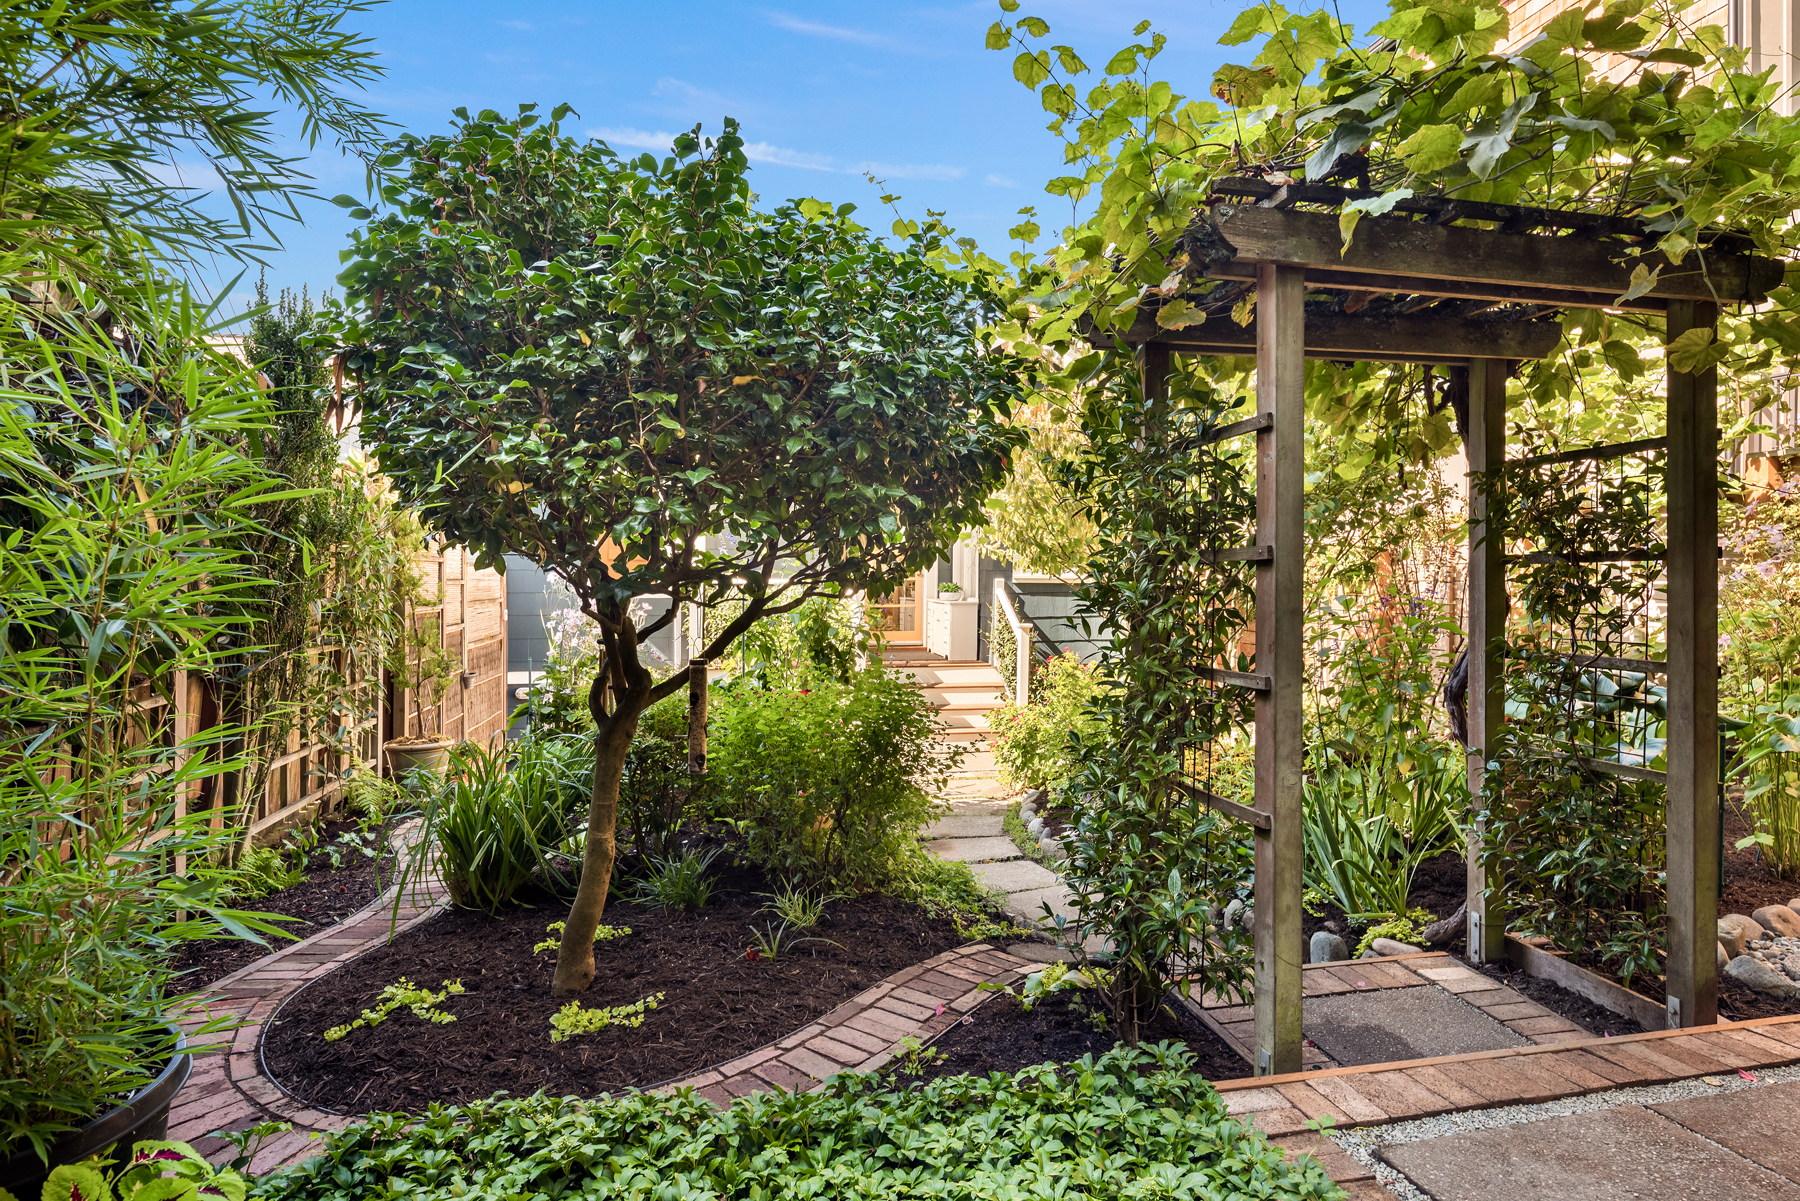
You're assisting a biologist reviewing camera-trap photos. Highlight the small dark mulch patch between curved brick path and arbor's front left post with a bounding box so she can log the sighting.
[895,990,1249,1082]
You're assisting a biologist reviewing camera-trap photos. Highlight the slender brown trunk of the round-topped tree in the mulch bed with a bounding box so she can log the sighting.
[551,619,652,998]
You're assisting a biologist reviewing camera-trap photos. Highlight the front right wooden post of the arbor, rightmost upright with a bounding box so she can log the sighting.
[1665,301,1719,1026]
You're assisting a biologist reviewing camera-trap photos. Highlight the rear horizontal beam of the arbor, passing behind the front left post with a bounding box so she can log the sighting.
[1094,306,1562,362]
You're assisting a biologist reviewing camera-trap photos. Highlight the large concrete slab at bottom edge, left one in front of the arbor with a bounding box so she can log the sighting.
[1379,1106,1800,1201]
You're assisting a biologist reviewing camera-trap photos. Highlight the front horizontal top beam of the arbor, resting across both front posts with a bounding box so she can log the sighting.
[1202,205,1782,303]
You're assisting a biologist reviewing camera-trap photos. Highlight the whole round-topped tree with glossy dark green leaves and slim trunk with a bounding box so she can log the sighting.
[335,106,1022,996]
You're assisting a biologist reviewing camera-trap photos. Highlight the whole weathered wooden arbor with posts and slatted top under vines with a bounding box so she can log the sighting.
[1100,189,1782,1075]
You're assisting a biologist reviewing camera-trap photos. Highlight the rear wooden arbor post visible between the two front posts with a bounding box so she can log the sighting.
[1458,358,1507,963]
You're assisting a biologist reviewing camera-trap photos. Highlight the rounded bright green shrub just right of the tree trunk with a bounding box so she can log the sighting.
[709,666,945,888]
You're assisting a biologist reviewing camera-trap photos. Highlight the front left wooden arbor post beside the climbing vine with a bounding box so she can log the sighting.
[1253,263,1307,1075]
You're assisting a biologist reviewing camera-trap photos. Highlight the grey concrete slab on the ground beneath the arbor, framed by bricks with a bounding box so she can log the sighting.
[1301,987,1532,1068]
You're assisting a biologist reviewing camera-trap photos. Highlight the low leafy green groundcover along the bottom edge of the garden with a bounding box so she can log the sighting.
[252,1044,1343,1201]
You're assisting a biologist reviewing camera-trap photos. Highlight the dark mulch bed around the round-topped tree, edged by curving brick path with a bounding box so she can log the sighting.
[265,871,963,1113]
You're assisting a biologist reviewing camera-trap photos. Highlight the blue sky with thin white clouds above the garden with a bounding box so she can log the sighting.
[221,0,1386,308]
